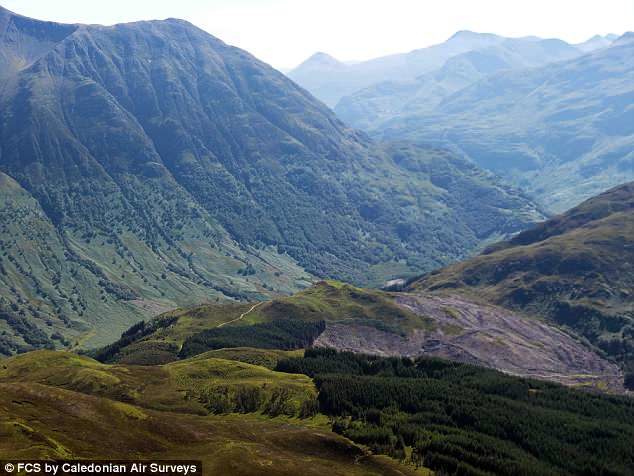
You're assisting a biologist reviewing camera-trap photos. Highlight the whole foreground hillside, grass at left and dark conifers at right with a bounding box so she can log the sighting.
[0,349,634,476]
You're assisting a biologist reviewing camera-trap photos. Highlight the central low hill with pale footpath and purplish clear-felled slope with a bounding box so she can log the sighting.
[95,282,623,392]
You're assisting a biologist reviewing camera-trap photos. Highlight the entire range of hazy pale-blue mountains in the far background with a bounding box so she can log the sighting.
[289,32,634,213]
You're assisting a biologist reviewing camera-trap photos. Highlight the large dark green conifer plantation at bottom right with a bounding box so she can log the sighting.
[276,349,634,475]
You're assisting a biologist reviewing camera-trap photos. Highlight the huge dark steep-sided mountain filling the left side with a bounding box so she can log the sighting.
[0,4,542,353]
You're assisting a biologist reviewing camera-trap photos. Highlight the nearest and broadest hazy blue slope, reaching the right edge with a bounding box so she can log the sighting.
[377,34,634,211]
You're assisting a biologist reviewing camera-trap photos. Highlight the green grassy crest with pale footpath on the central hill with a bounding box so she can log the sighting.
[96,281,436,366]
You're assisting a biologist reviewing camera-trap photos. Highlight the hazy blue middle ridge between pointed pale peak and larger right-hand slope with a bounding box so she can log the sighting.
[336,38,581,130]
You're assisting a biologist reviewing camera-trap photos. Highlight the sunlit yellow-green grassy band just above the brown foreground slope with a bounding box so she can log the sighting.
[0,351,316,416]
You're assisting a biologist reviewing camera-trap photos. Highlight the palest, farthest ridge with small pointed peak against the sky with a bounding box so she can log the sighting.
[288,31,504,107]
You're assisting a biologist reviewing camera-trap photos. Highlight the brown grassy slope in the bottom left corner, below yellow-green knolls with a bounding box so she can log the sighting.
[0,383,424,476]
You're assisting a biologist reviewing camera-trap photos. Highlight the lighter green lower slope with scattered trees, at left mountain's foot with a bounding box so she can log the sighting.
[0,173,309,355]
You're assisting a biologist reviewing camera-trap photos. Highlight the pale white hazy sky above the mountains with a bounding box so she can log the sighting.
[0,0,634,68]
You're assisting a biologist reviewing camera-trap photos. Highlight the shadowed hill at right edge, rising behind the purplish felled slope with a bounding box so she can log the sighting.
[410,183,634,362]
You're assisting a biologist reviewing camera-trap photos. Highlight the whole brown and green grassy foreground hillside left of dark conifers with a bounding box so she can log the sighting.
[0,351,426,476]
